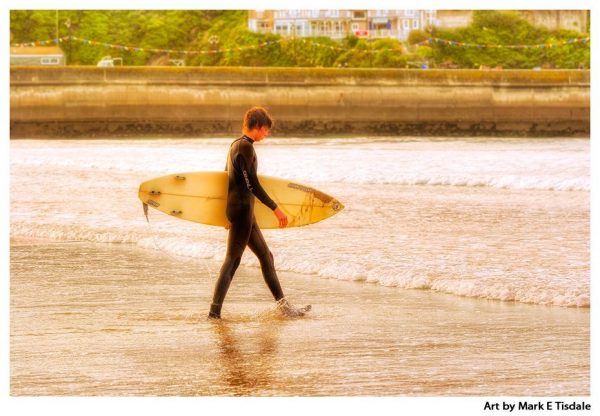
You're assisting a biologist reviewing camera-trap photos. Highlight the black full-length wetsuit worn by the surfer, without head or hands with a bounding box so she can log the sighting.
[210,135,283,317]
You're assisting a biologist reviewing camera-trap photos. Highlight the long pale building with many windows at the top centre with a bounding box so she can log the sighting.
[248,10,435,40]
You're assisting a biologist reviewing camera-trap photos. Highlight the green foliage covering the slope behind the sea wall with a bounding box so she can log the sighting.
[10,10,590,68]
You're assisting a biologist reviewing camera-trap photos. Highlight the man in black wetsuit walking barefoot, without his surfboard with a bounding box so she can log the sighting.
[208,107,307,319]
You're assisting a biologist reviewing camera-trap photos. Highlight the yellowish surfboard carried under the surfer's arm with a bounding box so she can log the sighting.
[138,172,344,229]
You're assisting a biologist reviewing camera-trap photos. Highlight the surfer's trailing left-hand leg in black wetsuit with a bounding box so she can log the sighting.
[209,206,253,318]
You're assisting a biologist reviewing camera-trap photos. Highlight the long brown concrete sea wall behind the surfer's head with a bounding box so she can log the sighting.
[10,67,590,138]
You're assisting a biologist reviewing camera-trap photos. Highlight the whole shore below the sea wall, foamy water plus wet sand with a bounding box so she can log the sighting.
[10,137,590,396]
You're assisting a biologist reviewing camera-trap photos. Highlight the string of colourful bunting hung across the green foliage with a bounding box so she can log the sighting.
[11,36,590,55]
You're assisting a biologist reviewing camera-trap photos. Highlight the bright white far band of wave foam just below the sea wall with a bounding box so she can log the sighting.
[11,139,590,191]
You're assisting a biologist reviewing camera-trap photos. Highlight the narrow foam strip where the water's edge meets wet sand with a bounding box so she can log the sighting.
[11,219,590,307]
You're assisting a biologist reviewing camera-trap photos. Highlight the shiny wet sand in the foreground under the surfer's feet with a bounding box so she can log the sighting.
[10,240,590,396]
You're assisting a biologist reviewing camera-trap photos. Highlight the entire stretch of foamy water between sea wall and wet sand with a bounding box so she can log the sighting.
[11,139,590,307]
